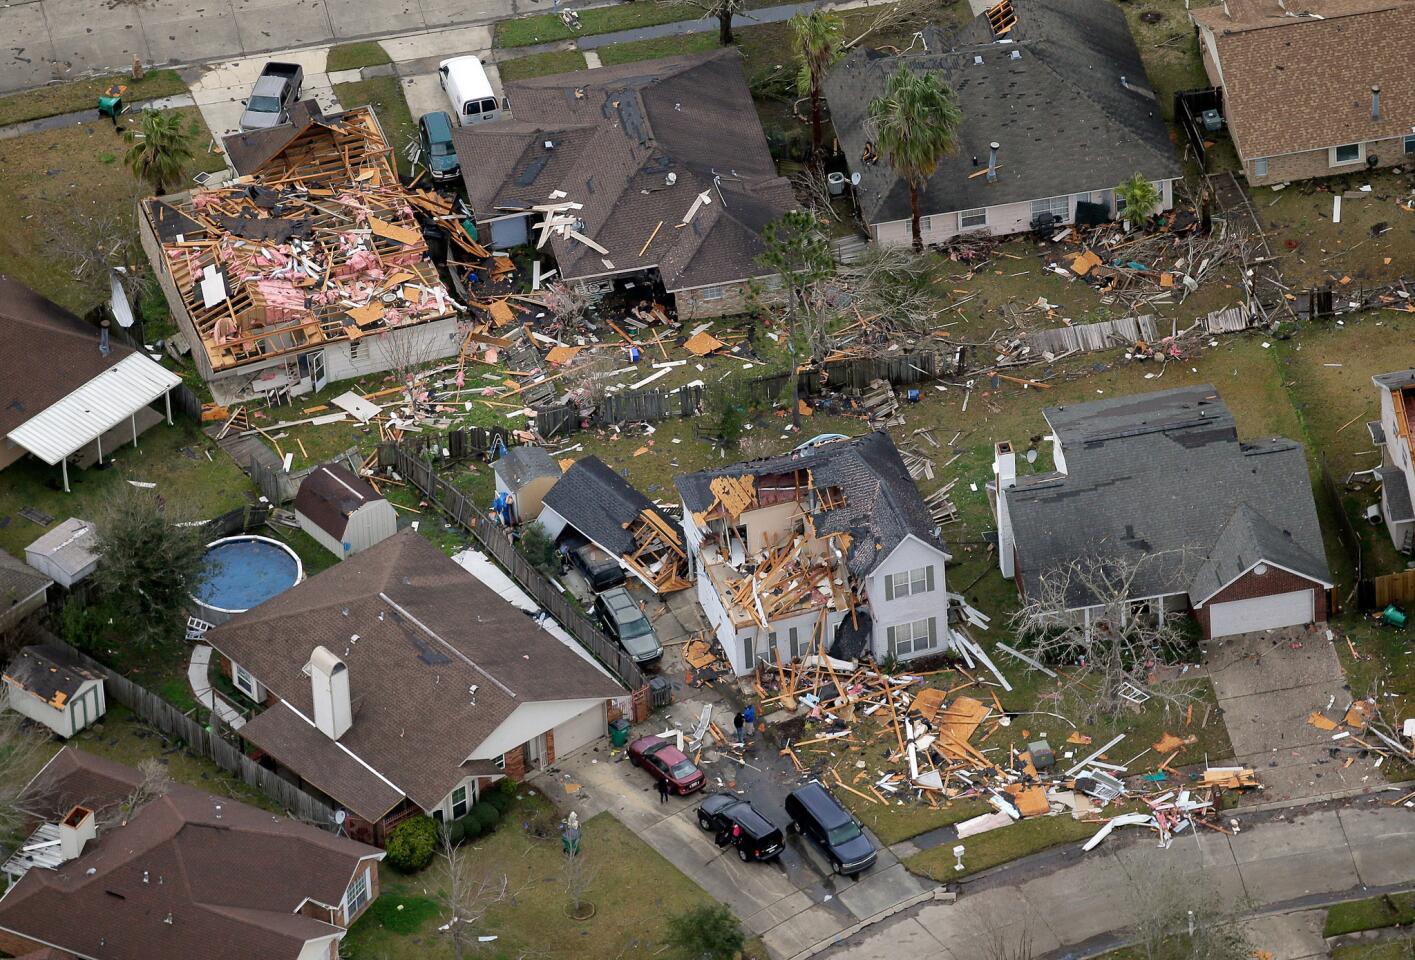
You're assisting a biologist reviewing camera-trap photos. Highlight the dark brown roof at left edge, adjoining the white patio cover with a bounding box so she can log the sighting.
[0,273,133,436]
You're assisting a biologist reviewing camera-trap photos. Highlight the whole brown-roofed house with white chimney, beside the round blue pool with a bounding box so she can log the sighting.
[205,530,628,844]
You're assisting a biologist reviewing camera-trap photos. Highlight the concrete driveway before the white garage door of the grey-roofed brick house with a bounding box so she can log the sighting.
[1206,624,1382,803]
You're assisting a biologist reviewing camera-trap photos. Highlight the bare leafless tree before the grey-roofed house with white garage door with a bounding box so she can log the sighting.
[1012,552,1199,722]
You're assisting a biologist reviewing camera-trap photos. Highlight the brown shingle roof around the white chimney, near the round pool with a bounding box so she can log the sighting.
[207,530,624,816]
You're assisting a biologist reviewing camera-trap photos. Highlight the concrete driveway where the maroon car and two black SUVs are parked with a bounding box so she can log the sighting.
[536,690,931,957]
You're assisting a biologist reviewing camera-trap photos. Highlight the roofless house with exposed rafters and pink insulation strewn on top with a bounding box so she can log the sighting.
[139,105,461,404]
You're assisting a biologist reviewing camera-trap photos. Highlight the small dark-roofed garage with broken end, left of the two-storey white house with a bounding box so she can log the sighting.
[536,455,692,593]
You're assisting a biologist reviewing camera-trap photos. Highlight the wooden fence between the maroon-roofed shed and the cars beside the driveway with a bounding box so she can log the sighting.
[396,446,648,691]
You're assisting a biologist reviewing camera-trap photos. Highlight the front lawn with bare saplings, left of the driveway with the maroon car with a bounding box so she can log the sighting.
[344,792,708,960]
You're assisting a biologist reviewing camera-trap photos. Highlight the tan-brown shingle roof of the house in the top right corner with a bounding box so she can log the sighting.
[1193,0,1415,159]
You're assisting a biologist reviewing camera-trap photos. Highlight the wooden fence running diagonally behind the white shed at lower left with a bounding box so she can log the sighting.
[45,636,337,831]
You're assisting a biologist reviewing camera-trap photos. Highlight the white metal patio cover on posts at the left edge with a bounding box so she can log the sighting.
[8,353,181,493]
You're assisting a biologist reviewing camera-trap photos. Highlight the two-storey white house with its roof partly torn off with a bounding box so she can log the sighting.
[675,430,949,675]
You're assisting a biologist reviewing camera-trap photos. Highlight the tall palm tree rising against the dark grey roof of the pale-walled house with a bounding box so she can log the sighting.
[870,64,964,251]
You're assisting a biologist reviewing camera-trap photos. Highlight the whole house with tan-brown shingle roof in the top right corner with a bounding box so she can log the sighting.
[1189,0,1415,187]
